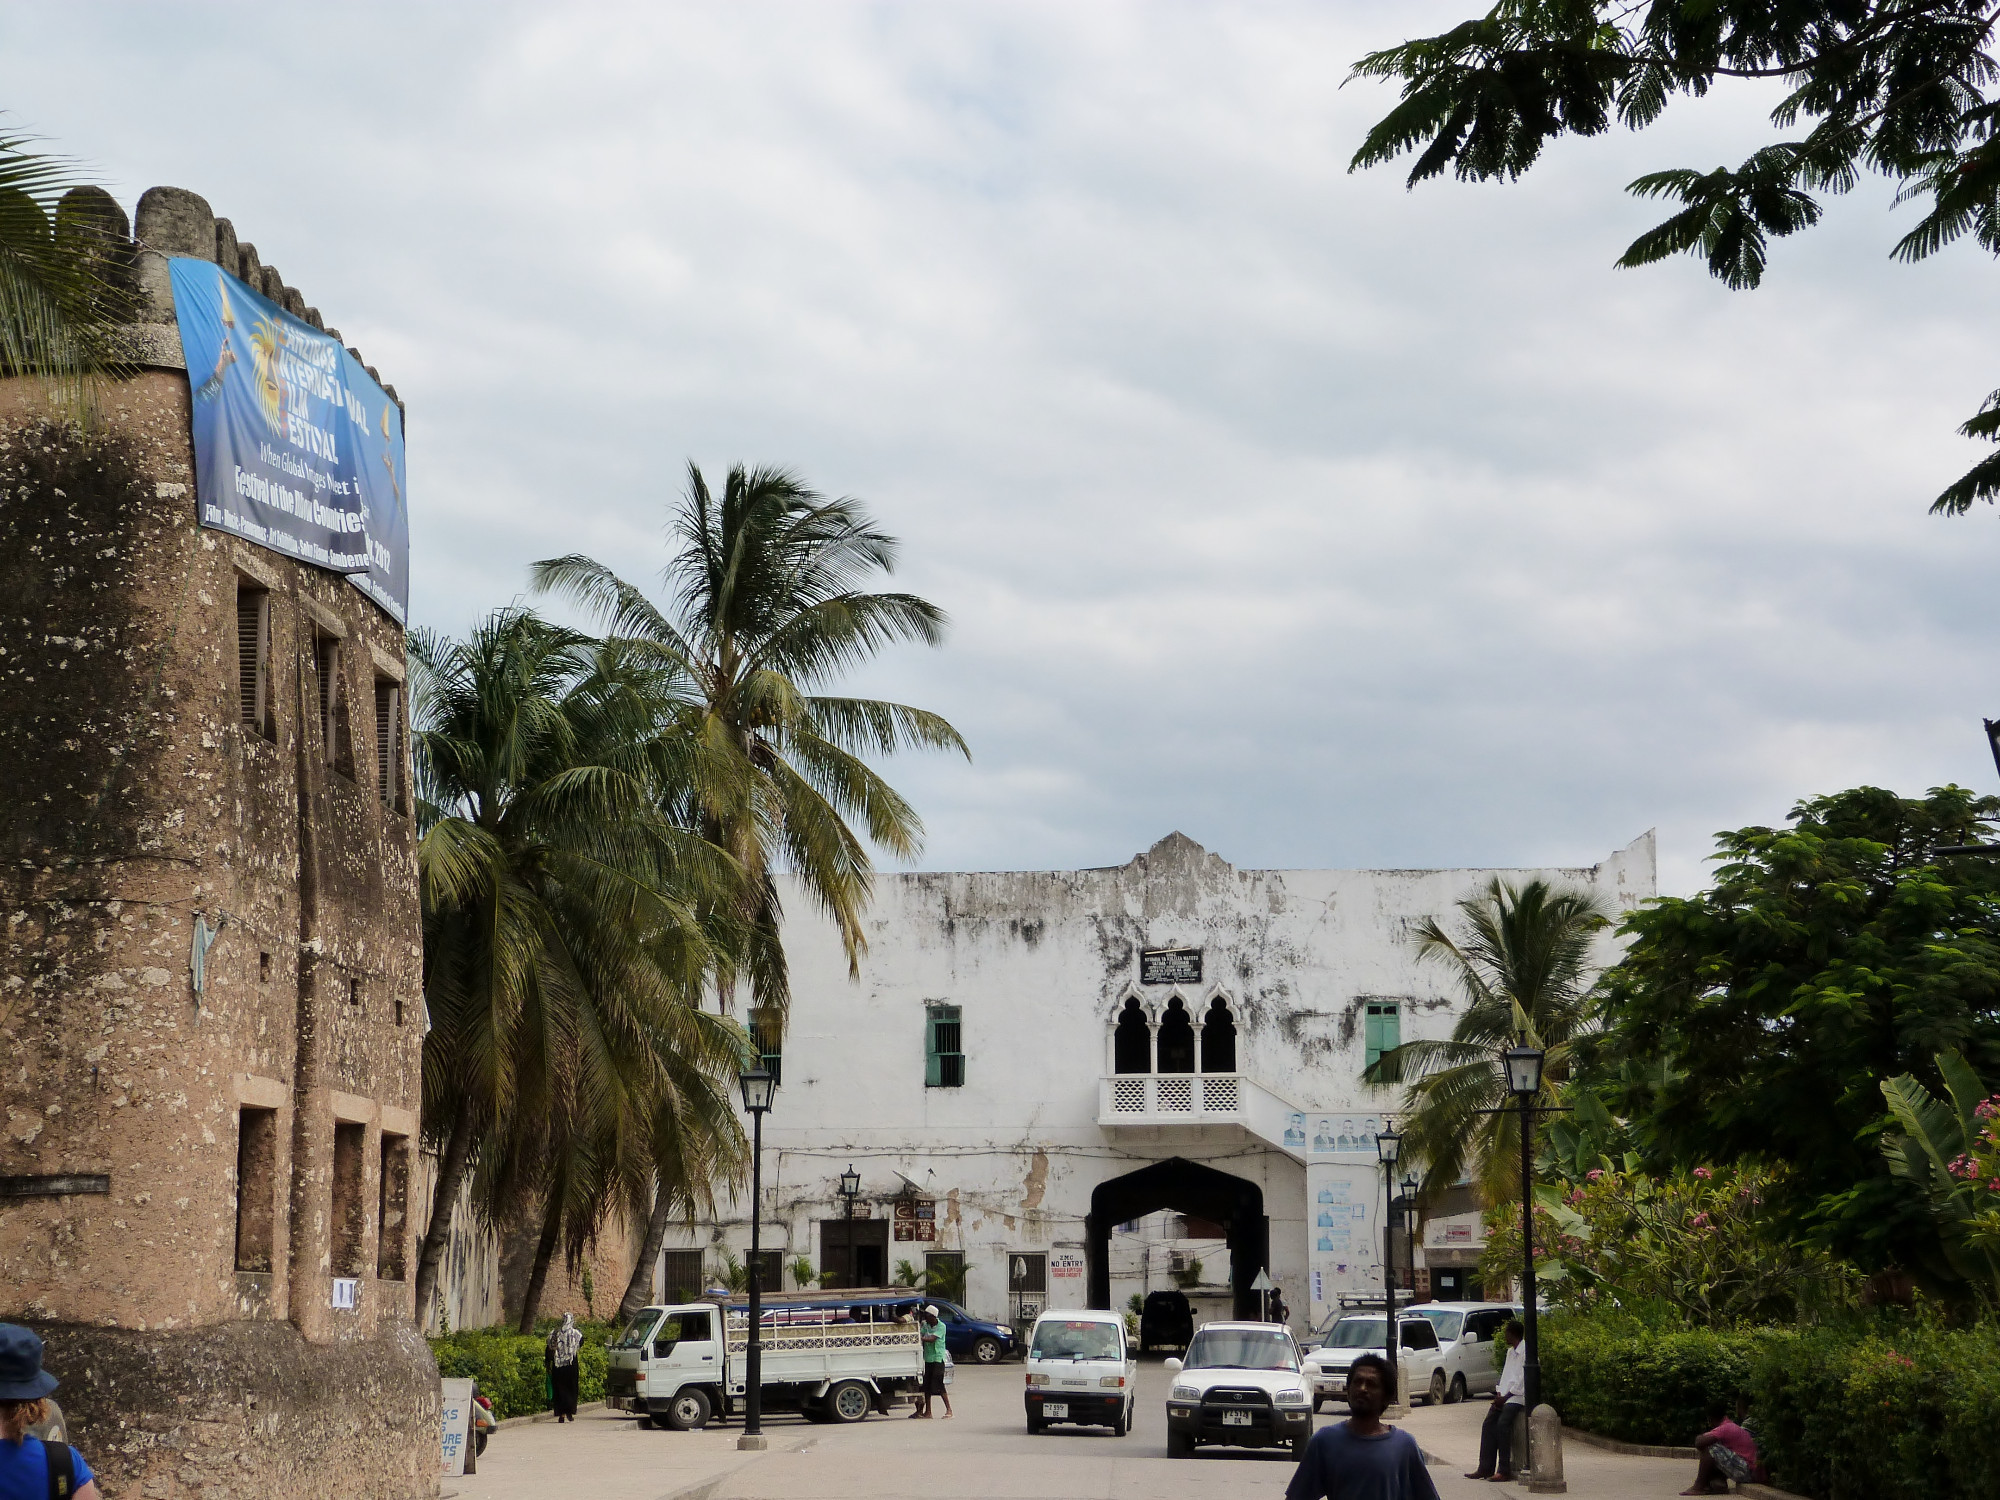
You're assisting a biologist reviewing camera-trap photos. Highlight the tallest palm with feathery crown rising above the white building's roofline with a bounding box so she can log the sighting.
[534,464,970,1304]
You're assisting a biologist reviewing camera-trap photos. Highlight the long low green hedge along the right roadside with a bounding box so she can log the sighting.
[1542,1316,2000,1500]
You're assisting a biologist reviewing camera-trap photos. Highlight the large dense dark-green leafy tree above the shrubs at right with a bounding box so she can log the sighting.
[1590,786,2000,1270]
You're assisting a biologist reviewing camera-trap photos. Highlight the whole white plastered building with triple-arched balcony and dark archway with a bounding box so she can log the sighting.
[672,834,1656,1324]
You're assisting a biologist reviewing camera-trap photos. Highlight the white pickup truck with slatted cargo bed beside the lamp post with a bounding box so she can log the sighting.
[604,1292,924,1432]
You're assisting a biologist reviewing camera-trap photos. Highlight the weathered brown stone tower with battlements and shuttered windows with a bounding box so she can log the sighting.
[0,188,438,1500]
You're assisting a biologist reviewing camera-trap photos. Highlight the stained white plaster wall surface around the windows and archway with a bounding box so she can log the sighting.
[668,834,1654,1322]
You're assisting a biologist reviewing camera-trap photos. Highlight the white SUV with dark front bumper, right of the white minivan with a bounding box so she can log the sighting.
[1166,1322,1312,1458]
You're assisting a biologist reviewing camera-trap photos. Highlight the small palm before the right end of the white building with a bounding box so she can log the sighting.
[1364,878,1610,1202]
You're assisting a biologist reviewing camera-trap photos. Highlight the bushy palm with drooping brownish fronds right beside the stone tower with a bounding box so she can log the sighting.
[410,610,744,1310]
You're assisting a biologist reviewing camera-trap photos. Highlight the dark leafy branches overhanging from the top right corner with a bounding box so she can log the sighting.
[1354,0,2000,514]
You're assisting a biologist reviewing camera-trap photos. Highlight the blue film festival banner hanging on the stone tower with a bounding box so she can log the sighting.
[168,256,410,624]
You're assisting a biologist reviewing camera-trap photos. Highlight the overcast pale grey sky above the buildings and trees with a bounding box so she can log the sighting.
[0,0,2000,890]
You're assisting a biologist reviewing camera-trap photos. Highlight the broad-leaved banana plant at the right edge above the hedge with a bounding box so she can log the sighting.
[1882,1052,2000,1308]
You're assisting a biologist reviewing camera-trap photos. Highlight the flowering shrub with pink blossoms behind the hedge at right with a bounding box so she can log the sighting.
[1480,1158,1838,1326]
